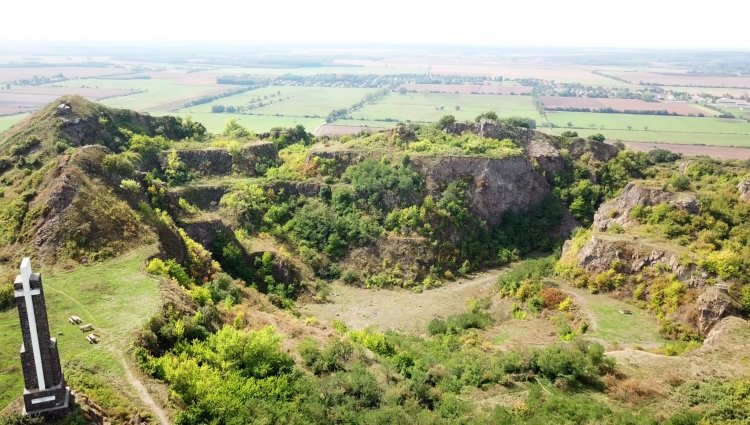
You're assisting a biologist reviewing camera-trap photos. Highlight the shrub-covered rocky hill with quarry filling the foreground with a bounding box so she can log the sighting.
[0,97,750,424]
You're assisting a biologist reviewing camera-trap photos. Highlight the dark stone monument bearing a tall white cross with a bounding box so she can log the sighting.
[13,257,71,417]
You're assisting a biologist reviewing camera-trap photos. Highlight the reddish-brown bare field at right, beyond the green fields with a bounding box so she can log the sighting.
[540,96,718,116]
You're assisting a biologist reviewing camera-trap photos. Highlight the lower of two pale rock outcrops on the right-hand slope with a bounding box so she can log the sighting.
[563,234,708,287]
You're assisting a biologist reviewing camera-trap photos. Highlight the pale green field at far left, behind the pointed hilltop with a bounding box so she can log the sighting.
[46,78,226,111]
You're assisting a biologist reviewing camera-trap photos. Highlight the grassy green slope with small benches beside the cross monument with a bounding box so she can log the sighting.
[0,248,160,411]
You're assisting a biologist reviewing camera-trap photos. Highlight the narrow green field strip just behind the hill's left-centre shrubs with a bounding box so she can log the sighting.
[169,112,325,133]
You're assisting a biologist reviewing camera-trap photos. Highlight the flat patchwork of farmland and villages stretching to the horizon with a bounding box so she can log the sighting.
[0,51,750,149]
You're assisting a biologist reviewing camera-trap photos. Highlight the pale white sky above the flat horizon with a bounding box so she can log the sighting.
[0,0,750,50]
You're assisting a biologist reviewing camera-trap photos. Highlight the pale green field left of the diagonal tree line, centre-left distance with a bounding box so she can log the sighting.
[180,86,375,118]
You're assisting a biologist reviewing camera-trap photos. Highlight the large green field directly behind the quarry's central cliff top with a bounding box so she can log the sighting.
[350,93,542,123]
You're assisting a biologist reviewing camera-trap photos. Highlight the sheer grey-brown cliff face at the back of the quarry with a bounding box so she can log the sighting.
[412,156,550,225]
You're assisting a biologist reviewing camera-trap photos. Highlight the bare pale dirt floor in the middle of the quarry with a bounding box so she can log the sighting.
[300,270,503,333]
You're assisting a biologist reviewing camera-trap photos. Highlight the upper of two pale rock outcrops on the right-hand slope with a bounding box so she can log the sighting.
[593,183,700,231]
